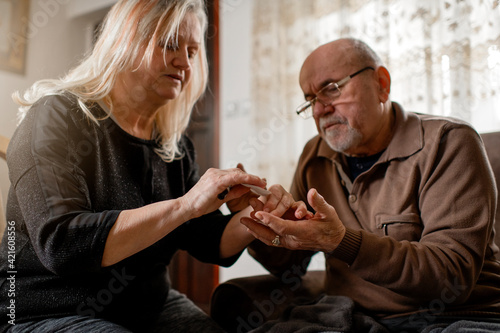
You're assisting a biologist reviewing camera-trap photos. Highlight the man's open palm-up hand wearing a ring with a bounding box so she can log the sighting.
[241,189,345,252]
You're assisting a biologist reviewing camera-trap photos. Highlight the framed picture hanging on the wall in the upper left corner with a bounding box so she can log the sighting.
[0,0,30,74]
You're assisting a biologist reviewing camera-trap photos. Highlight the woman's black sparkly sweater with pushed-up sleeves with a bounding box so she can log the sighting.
[0,96,237,331]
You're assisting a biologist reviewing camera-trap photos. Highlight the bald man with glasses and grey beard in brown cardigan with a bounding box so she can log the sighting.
[242,38,500,332]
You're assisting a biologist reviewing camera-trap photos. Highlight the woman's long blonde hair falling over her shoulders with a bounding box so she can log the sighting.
[13,0,208,162]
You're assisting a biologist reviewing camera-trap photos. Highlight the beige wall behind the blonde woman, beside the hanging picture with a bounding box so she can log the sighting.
[0,0,111,232]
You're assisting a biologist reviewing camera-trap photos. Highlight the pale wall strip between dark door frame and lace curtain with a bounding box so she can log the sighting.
[219,0,267,282]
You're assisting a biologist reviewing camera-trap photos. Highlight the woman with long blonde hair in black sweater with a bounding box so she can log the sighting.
[0,0,307,332]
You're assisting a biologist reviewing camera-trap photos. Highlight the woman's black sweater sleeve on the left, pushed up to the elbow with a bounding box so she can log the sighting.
[9,96,120,275]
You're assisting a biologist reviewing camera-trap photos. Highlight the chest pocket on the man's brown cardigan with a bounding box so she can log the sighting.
[375,213,423,241]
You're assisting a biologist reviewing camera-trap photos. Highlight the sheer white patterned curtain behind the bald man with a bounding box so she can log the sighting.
[250,0,500,186]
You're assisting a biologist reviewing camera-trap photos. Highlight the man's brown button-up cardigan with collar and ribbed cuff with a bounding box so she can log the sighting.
[250,103,500,319]
